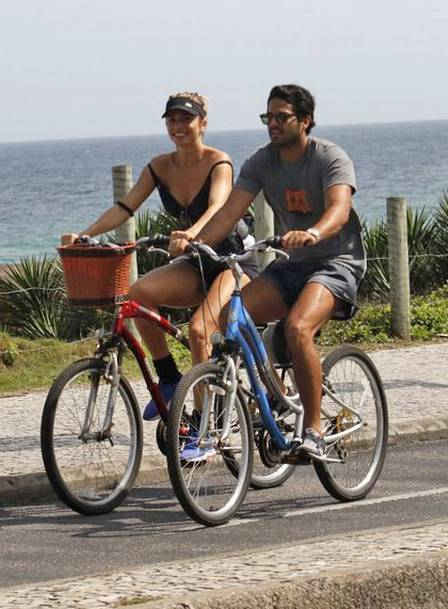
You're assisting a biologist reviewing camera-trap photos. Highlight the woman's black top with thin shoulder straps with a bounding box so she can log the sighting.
[148,161,247,255]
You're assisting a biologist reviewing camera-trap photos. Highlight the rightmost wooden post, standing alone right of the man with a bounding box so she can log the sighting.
[387,197,411,340]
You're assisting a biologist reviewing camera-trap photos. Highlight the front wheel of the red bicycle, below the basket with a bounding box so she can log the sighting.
[41,359,143,515]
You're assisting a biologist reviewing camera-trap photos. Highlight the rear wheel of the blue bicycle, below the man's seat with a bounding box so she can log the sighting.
[314,346,388,501]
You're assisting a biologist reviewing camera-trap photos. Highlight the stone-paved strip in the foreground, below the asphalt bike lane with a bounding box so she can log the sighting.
[0,523,448,609]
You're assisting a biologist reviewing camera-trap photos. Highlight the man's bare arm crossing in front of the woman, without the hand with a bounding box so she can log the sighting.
[196,188,255,245]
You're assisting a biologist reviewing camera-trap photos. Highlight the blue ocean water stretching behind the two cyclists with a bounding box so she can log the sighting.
[0,121,448,264]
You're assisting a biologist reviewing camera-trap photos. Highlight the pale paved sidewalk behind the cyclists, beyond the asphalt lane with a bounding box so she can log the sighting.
[0,343,448,502]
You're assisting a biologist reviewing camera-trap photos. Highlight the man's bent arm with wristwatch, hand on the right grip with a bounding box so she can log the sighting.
[282,184,352,249]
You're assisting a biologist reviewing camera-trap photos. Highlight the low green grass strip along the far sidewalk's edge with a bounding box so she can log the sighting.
[0,285,448,395]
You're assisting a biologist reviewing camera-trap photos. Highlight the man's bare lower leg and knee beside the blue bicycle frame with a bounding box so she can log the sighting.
[285,283,338,434]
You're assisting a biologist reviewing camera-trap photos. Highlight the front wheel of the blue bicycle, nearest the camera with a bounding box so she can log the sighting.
[166,362,253,526]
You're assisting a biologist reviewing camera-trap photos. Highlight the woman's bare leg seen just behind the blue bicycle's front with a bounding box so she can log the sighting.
[189,269,250,365]
